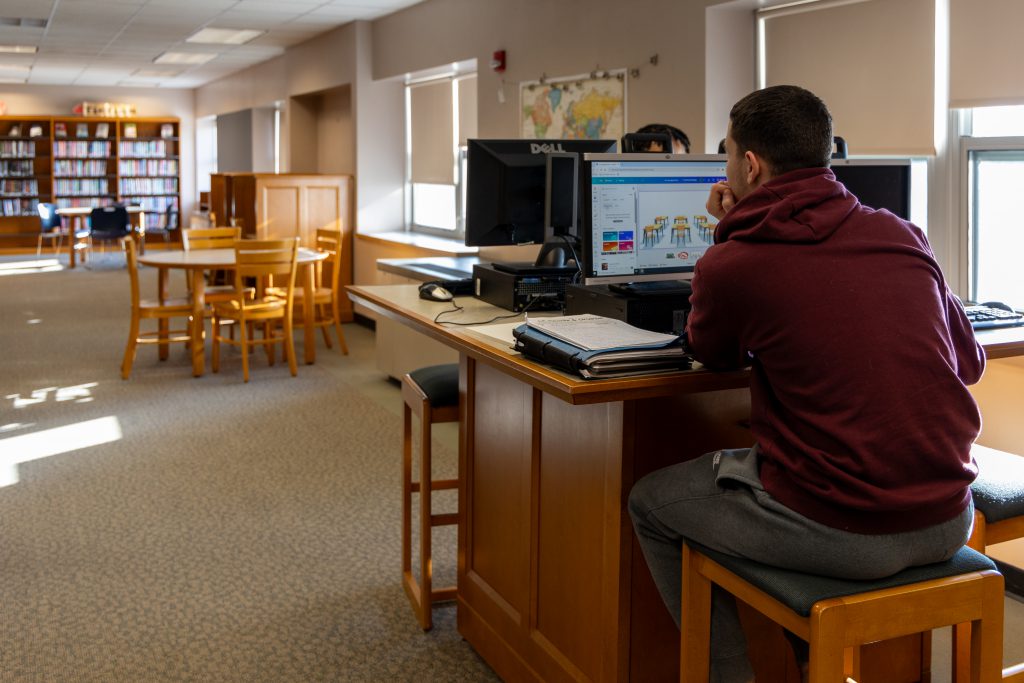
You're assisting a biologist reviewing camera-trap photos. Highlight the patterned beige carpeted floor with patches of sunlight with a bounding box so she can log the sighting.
[0,255,498,683]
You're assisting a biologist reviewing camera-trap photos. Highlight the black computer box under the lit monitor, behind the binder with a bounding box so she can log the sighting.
[565,285,690,335]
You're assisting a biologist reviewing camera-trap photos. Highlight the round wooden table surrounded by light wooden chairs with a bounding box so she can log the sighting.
[138,247,328,377]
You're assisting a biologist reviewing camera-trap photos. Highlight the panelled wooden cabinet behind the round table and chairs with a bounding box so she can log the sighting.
[210,173,354,319]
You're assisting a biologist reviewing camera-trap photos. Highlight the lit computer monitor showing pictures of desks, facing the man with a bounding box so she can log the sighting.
[581,154,725,285]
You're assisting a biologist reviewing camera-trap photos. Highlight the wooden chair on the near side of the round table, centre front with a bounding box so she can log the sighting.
[210,238,299,382]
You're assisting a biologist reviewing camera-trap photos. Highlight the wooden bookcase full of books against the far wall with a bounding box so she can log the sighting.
[0,116,181,249]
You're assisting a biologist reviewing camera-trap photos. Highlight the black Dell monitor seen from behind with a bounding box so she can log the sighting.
[466,139,615,247]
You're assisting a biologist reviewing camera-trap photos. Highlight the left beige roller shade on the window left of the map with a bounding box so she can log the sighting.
[410,79,455,184]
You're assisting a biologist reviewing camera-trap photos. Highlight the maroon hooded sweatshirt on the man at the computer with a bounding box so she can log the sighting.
[687,168,985,533]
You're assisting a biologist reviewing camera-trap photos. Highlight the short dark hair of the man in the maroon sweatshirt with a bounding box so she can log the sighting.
[729,85,833,175]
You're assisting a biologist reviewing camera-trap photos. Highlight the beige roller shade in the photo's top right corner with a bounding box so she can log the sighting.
[949,0,1024,108]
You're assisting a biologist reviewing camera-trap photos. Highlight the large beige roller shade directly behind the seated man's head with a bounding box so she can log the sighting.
[759,0,935,155]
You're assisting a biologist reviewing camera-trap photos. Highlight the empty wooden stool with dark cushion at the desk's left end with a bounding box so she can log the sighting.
[401,364,459,631]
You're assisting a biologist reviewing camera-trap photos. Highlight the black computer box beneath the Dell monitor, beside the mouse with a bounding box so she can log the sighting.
[473,263,579,312]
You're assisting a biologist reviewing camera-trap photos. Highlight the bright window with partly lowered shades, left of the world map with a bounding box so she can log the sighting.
[406,75,476,239]
